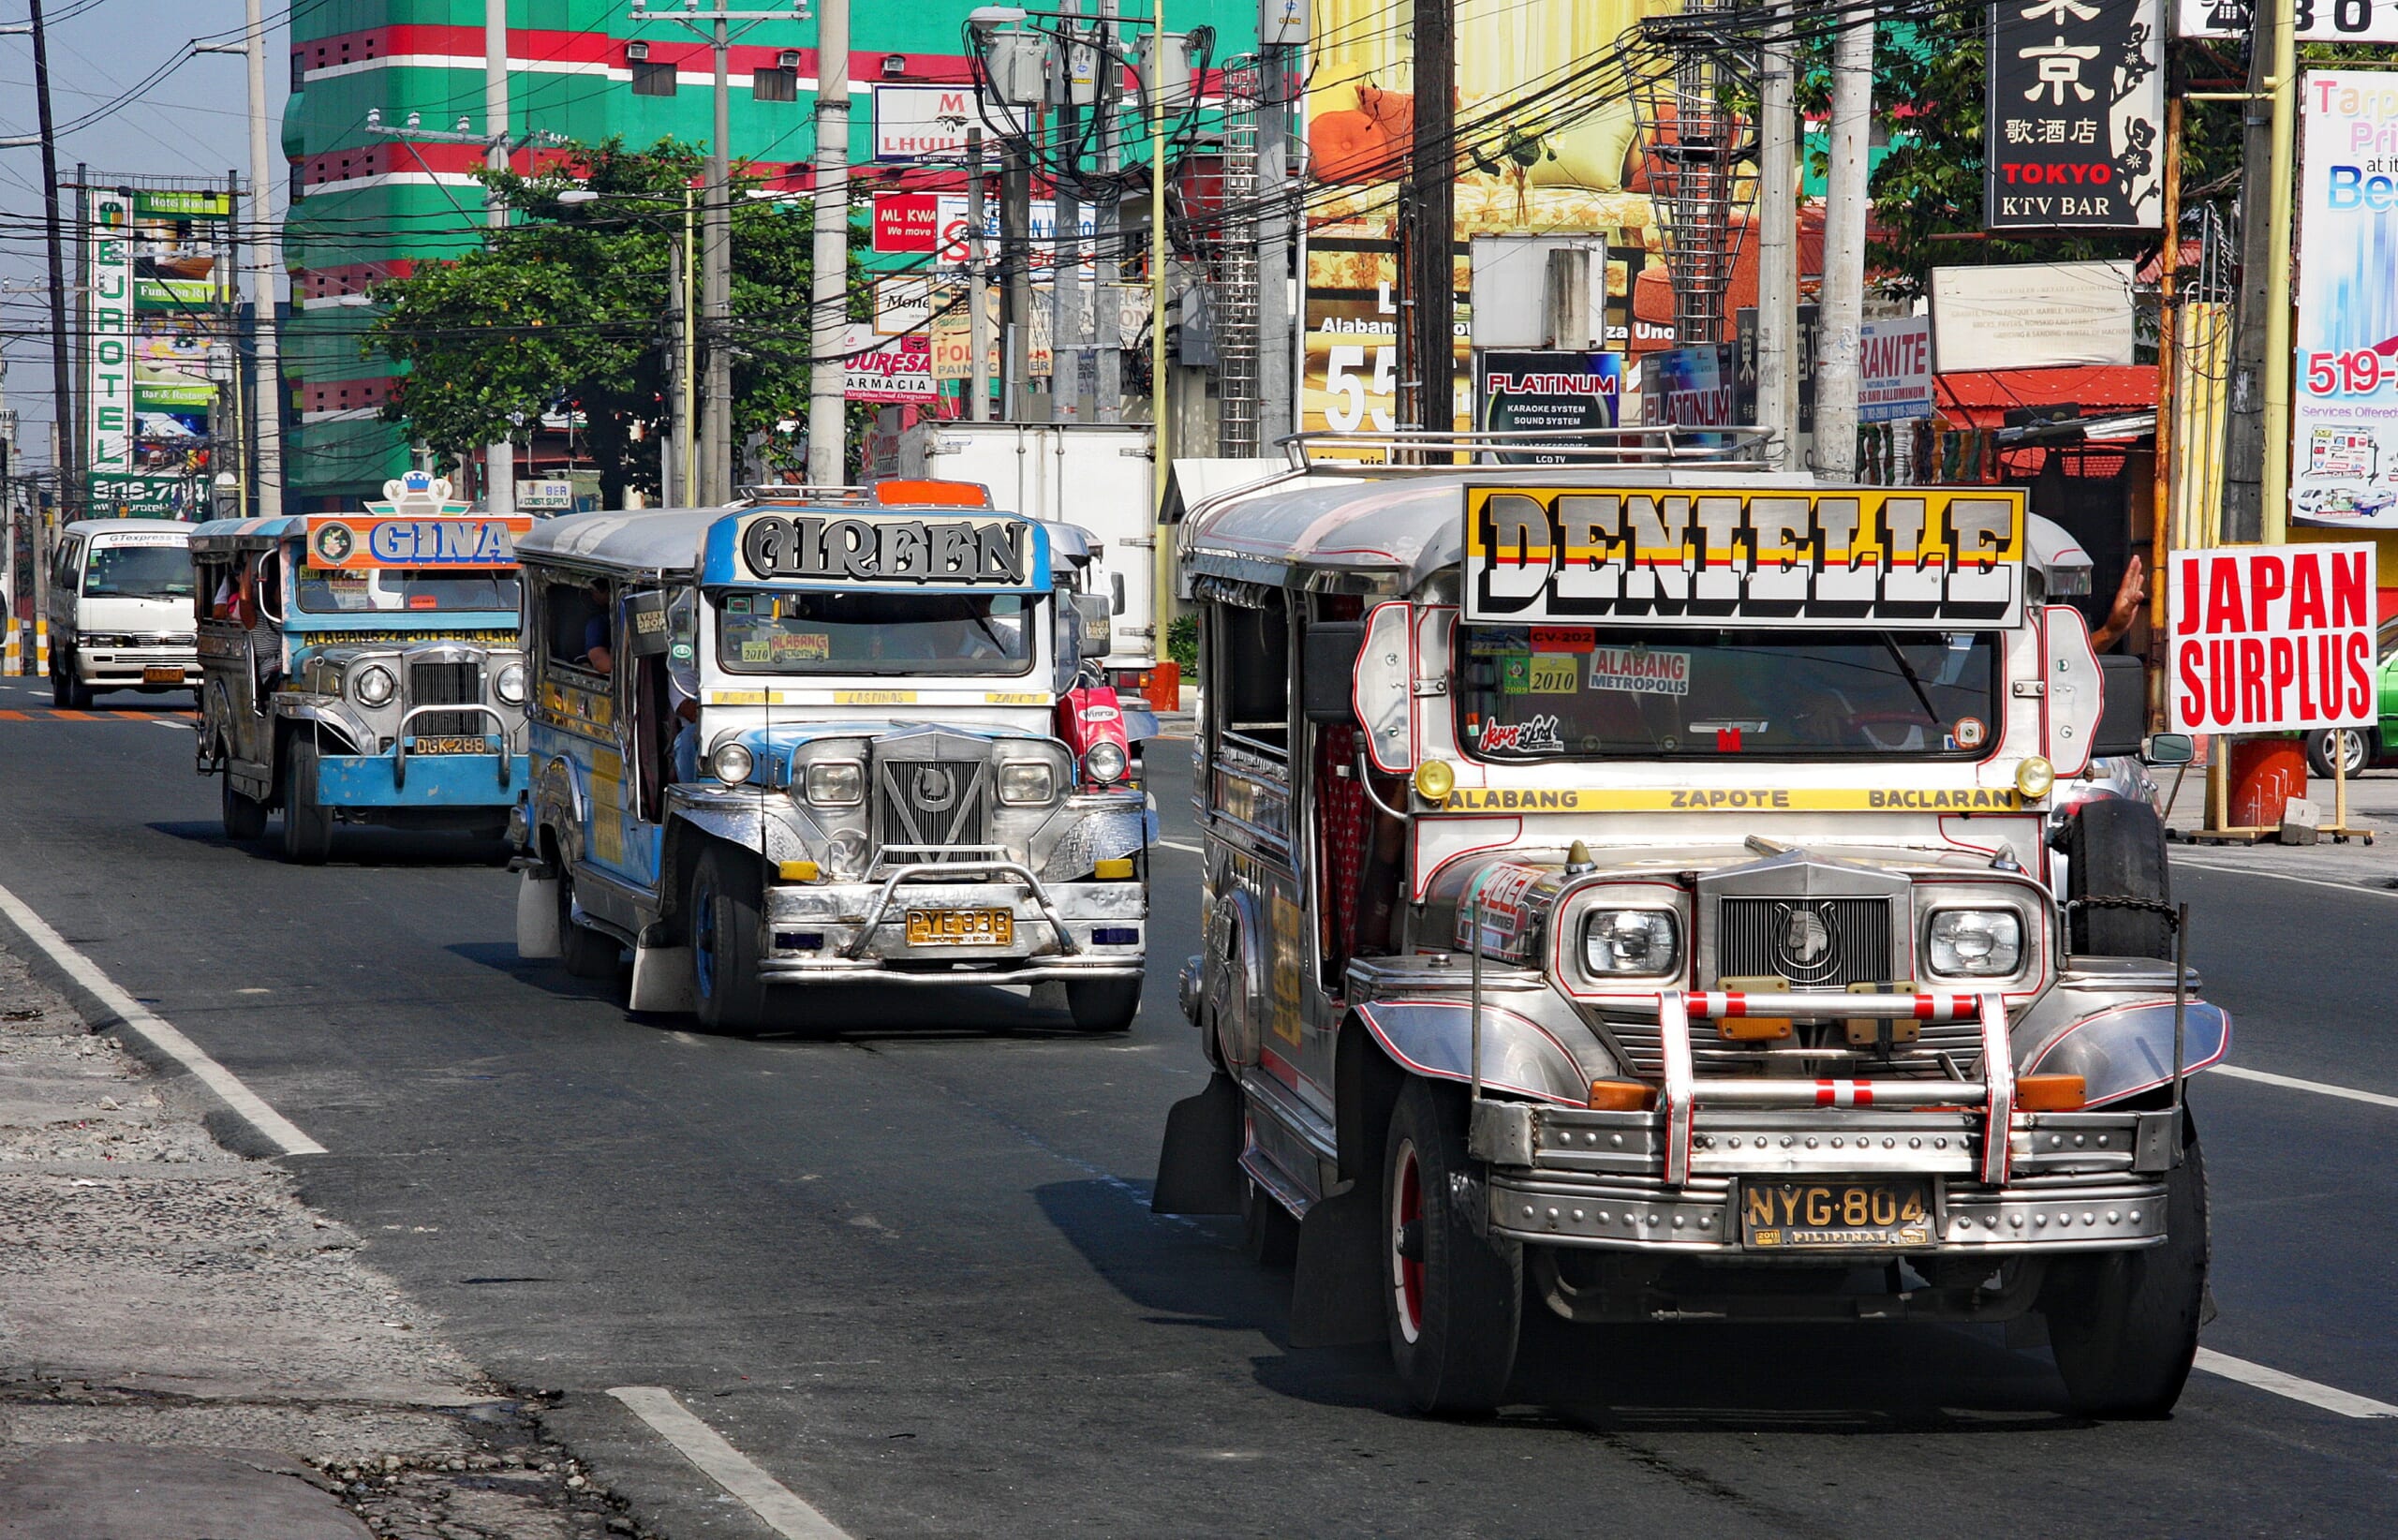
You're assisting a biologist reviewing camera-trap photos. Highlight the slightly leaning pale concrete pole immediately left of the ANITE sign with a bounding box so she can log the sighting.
[1813,9,1873,480]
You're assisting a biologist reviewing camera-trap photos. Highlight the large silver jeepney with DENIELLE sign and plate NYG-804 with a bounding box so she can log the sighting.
[1156,437,2230,1413]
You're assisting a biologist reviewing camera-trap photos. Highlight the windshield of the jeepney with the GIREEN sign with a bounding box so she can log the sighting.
[717,590,1033,674]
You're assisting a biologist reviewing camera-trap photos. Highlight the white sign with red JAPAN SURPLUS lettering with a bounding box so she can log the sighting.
[2166,544,2376,734]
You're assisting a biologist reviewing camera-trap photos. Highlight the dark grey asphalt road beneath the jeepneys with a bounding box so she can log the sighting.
[0,681,2398,1540]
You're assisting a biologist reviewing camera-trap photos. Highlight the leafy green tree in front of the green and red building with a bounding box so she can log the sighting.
[363,140,866,506]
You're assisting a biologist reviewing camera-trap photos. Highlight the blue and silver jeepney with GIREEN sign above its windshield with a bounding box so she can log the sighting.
[513,484,1156,1031]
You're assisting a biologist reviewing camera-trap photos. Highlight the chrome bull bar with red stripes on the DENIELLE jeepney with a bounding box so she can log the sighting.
[1659,991,2014,1188]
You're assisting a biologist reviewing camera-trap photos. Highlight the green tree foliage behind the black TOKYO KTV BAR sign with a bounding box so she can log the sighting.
[1798,0,2244,295]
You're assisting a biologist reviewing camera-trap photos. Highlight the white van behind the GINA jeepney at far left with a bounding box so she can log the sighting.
[51,518,199,707]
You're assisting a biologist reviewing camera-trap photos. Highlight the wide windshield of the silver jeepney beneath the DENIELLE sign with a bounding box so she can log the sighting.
[1458,624,2000,763]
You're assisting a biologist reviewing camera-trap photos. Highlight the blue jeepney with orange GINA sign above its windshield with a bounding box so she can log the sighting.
[192,478,532,864]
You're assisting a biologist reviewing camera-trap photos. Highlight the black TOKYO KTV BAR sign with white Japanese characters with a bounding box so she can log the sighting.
[1983,0,2166,235]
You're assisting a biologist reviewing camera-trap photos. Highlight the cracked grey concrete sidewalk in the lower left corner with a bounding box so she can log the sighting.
[0,953,638,1540]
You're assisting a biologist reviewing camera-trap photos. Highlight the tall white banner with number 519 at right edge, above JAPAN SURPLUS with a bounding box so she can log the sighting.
[2287,69,2398,530]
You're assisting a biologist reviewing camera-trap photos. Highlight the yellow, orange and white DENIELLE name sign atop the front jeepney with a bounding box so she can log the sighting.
[1465,484,2024,629]
